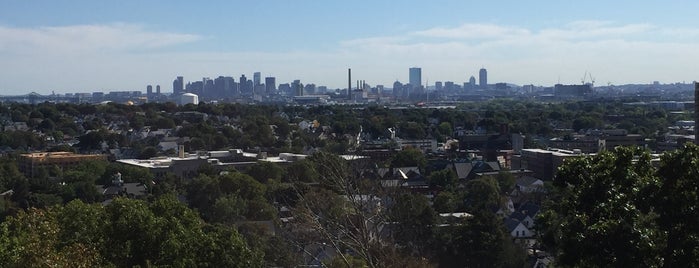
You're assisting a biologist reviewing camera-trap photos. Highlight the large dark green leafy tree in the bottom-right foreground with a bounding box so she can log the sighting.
[537,145,668,267]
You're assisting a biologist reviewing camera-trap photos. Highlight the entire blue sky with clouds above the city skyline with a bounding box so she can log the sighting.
[0,0,699,95]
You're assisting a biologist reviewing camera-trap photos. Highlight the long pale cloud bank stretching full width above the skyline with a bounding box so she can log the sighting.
[0,21,699,95]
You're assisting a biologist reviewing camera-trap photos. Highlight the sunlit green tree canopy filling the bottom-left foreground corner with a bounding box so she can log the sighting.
[0,196,263,267]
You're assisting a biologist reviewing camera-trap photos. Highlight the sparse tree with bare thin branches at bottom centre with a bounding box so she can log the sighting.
[294,152,387,267]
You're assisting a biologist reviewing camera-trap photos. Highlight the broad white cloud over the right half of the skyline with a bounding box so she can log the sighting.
[332,21,699,85]
